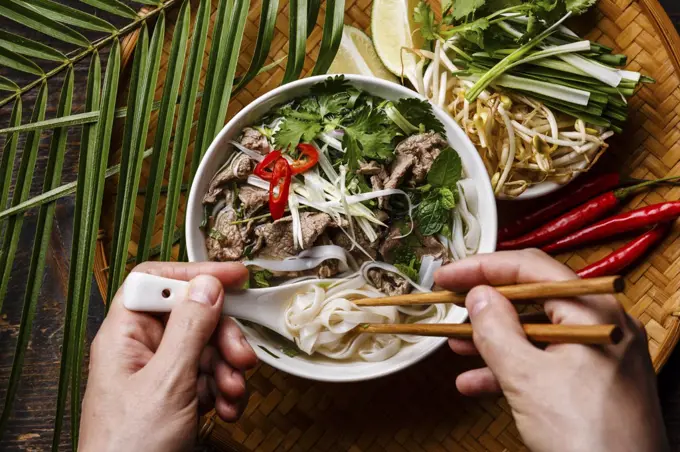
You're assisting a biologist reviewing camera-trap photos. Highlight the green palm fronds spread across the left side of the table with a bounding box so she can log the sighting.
[0,0,344,450]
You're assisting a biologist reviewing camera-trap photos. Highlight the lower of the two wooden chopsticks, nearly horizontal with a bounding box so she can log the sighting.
[356,323,623,345]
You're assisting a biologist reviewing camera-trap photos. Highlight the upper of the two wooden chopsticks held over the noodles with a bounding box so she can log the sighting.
[352,276,624,306]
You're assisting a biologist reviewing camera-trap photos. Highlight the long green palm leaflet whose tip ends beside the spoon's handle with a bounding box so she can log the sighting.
[107,13,165,296]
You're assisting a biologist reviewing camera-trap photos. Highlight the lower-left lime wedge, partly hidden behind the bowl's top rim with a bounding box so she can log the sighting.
[328,25,397,82]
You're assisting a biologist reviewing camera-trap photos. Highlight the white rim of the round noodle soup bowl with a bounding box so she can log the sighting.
[185,74,498,383]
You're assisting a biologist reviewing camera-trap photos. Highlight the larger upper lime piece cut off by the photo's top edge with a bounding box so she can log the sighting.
[371,0,423,81]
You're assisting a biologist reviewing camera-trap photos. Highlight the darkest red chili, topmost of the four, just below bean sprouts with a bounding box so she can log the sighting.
[498,173,622,242]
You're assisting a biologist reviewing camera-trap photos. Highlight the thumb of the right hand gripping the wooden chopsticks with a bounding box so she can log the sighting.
[465,286,540,385]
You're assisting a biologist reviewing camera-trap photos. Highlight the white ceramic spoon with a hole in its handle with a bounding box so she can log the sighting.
[123,272,338,341]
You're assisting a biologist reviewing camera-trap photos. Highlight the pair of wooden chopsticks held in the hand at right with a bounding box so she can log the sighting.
[354,276,624,344]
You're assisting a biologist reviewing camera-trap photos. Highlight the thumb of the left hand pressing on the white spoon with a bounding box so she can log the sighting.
[153,275,224,376]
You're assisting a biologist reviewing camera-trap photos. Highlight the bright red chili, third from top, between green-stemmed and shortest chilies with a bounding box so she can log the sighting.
[543,201,680,253]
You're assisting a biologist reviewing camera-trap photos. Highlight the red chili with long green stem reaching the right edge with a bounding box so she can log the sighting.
[497,176,678,250]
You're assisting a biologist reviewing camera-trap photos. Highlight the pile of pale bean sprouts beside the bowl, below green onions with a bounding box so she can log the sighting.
[412,41,613,196]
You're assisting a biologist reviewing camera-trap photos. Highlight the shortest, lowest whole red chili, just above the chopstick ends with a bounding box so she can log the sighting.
[576,223,670,278]
